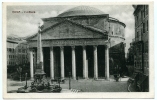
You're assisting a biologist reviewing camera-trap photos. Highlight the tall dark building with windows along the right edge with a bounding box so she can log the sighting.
[133,5,149,91]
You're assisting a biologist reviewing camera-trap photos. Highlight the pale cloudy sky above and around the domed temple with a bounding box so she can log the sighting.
[7,5,135,53]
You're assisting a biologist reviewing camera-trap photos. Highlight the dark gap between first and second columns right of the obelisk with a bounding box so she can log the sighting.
[53,47,61,79]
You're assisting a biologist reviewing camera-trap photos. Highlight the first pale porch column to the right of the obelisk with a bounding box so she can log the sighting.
[50,47,54,79]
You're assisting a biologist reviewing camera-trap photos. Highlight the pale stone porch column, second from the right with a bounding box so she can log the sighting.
[94,46,98,79]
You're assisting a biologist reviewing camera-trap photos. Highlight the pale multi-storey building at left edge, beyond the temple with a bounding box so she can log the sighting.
[7,36,29,67]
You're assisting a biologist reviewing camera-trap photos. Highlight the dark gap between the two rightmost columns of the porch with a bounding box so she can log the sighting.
[97,45,105,78]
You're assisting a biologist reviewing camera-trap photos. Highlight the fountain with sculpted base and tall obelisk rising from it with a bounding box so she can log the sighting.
[17,24,62,93]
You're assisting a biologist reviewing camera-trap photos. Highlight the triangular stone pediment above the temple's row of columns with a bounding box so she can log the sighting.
[30,21,107,40]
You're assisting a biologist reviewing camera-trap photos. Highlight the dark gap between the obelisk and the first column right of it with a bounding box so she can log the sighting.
[43,47,50,77]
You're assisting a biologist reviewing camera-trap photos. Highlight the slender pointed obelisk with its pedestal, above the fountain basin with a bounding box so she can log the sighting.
[35,23,45,75]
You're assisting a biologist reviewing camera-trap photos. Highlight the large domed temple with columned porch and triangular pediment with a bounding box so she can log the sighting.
[27,6,126,80]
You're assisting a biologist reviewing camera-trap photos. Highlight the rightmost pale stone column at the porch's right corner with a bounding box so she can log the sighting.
[105,46,109,80]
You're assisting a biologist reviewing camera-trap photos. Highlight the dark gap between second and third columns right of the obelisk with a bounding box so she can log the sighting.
[64,46,72,77]
